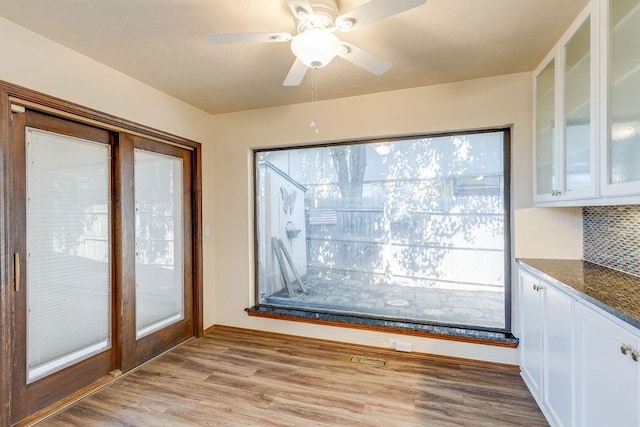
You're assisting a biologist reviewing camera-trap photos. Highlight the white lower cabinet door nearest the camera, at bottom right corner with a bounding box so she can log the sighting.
[575,304,640,427]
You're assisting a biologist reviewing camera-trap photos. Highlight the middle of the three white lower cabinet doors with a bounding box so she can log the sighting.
[543,284,573,426]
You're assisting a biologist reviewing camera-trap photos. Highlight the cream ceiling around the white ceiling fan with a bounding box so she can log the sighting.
[0,0,587,114]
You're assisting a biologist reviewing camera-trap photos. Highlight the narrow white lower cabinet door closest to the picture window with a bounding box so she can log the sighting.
[520,271,542,403]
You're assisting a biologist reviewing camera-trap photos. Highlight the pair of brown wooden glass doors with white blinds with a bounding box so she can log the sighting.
[9,111,194,422]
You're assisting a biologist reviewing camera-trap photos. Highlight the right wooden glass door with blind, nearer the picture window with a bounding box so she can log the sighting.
[133,137,193,364]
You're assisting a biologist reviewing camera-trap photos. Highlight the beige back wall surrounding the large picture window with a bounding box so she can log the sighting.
[214,73,579,364]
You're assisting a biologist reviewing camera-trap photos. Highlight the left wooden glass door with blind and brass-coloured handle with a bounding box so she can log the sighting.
[10,113,115,420]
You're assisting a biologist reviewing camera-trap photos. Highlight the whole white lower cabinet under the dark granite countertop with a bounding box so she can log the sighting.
[519,269,640,427]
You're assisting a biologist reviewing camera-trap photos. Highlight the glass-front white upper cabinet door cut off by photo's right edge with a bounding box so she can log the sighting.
[603,0,640,196]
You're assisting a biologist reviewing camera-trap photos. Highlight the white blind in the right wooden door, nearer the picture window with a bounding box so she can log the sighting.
[134,149,184,338]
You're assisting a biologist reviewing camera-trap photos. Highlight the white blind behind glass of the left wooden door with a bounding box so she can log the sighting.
[26,128,111,381]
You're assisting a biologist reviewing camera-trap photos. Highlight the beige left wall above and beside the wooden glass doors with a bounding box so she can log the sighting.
[0,17,215,324]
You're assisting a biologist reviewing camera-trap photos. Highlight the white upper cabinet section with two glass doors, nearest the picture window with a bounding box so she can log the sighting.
[534,5,597,203]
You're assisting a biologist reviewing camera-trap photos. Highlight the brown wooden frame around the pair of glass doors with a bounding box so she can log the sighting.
[0,81,203,427]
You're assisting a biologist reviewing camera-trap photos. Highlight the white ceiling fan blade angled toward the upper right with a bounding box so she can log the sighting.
[336,0,427,31]
